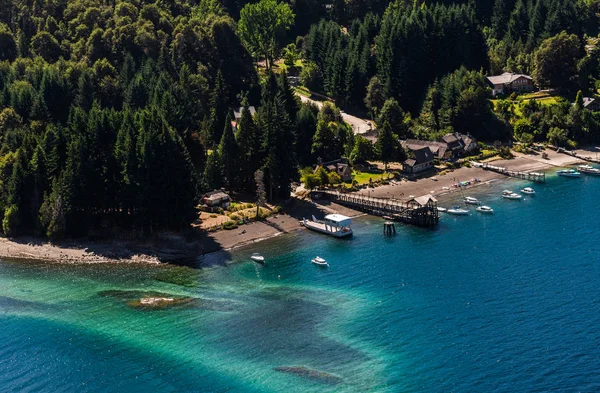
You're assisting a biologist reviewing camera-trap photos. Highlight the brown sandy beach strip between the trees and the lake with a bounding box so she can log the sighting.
[0,150,595,266]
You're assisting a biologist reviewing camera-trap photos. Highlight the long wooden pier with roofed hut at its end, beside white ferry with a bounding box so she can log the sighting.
[323,191,439,227]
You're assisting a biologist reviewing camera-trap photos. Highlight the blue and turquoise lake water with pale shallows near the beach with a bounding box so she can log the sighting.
[0,177,600,393]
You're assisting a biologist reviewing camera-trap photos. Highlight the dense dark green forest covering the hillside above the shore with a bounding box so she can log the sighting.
[0,0,600,245]
